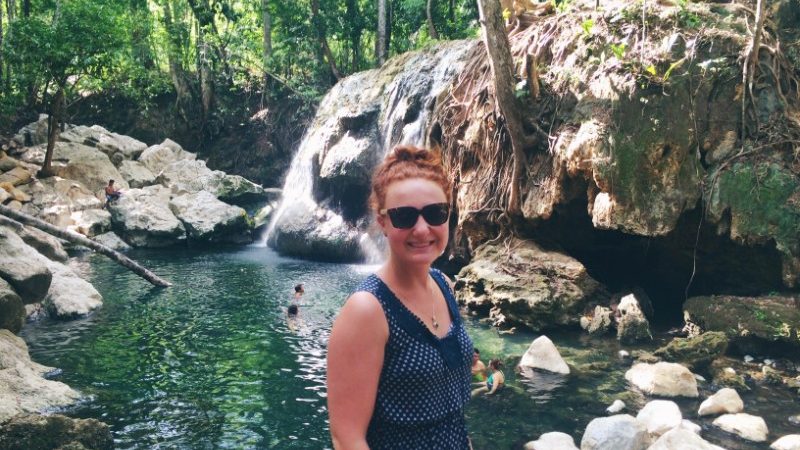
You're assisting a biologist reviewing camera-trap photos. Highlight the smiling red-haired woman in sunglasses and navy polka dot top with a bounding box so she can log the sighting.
[328,146,472,450]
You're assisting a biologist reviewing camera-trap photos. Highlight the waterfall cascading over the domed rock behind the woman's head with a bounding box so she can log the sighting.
[261,41,476,263]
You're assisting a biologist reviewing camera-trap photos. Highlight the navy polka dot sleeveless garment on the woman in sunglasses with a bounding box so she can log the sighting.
[357,269,472,450]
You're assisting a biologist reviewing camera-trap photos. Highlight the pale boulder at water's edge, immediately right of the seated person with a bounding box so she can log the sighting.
[109,185,186,247]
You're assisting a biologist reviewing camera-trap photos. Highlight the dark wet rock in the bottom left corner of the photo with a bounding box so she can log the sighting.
[0,414,114,450]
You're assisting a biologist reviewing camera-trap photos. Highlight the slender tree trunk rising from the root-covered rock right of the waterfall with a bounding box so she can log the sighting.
[478,0,526,215]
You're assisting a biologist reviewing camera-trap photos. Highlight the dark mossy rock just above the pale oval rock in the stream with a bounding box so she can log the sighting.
[654,331,728,371]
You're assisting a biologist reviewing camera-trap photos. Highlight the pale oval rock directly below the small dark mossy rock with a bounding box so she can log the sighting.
[625,362,698,398]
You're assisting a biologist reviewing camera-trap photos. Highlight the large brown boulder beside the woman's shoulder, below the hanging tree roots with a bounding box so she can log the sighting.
[456,239,604,330]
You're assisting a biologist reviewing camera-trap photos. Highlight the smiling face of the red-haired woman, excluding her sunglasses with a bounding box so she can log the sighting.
[378,178,448,265]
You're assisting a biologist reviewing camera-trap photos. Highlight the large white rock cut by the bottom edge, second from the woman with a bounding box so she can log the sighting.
[581,414,650,450]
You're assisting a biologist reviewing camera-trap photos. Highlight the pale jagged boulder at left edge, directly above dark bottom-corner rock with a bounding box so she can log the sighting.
[0,330,80,423]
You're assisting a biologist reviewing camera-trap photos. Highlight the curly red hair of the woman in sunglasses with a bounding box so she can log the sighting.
[369,145,452,211]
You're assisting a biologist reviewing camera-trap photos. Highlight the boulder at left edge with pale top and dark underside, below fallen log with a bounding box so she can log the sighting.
[0,226,53,304]
